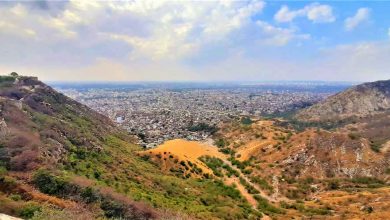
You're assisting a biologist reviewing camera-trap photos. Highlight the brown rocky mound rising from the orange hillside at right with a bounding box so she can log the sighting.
[280,131,389,178]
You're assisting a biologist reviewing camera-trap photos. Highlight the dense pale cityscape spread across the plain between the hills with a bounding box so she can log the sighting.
[55,84,348,148]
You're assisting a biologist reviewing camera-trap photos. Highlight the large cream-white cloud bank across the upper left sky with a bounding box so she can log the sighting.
[0,0,307,62]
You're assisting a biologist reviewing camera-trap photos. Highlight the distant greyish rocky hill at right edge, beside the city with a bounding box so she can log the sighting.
[296,80,390,121]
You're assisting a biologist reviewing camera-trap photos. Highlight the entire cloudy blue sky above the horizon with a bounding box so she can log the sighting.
[0,0,390,82]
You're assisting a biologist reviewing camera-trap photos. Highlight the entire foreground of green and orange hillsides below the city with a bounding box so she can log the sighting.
[0,76,390,219]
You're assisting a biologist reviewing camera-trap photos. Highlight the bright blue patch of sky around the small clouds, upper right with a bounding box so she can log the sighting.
[254,1,390,46]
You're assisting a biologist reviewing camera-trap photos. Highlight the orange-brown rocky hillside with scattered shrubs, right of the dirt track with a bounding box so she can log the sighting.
[212,119,390,219]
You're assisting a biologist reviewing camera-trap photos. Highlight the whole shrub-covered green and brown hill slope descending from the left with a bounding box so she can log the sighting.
[0,76,260,219]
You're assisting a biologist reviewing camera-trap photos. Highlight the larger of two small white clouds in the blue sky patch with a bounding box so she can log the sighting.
[274,3,336,23]
